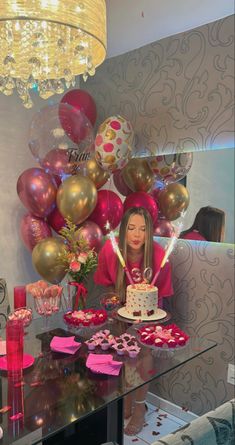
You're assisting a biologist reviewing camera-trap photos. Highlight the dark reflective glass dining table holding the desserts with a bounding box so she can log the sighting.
[0,313,216,445]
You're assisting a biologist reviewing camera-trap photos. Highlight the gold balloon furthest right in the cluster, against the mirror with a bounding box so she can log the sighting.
[158,183,189,221]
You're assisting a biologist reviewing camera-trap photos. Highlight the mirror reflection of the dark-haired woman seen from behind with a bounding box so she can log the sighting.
[180,206,225,243]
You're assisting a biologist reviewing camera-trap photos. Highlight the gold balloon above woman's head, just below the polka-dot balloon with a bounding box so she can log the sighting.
[122,159,154,192]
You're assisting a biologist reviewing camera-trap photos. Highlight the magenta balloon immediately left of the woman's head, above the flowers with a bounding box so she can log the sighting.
[89,190,123,235]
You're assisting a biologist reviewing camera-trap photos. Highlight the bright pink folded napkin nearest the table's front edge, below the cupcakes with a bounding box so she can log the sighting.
[86,354,122,375]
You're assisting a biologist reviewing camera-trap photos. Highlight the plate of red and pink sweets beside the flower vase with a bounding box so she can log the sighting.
[63,309,107,329]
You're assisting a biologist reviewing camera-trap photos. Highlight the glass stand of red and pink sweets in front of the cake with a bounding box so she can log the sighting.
[136,324,189,351]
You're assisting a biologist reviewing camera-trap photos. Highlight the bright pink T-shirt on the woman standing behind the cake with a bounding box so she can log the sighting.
[94,240,173,307]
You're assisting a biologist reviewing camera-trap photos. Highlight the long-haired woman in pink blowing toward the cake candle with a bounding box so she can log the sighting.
[94,207,173,435]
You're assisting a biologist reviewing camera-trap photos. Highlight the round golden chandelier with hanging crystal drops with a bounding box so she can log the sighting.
[0,0,106,108]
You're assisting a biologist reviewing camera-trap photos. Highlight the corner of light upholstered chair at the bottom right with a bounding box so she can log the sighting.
[152,399,235,445]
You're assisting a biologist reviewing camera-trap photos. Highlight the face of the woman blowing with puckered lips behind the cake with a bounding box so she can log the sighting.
[126,215,146,250]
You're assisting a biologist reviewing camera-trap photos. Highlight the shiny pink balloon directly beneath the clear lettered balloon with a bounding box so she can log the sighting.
[40,148,74,176]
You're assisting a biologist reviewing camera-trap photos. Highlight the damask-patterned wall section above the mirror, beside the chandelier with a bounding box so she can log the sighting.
[81,13,234,153]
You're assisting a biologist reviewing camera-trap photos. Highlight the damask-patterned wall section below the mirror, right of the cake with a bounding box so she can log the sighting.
[151,240,235,415]
